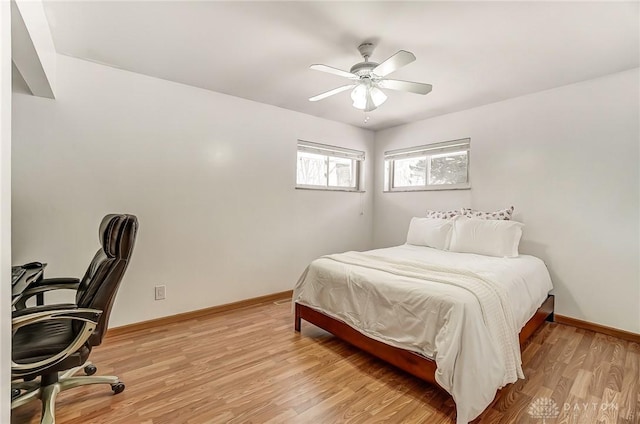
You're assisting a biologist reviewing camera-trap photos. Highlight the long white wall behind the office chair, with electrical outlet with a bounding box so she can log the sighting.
[12,56,373,327]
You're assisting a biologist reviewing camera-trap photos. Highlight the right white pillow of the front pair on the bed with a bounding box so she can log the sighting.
[449,216,524,258]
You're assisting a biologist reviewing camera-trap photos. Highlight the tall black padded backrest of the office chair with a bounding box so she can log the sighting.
[76,214,138,346]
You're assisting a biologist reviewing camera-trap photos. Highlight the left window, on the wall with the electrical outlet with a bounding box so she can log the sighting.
[296,140,364,191]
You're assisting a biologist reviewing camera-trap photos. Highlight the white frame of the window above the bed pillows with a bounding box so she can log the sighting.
[383,138,471,193]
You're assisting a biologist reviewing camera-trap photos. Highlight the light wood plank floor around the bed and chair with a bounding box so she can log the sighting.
[12,302,640,424]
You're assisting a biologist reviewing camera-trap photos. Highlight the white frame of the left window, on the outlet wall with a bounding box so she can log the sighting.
[295,140,365,193]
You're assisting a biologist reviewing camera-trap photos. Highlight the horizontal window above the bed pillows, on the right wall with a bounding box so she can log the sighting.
[384,138,471,191]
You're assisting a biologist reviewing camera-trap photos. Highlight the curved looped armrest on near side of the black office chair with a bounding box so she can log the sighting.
[11,304,102,378]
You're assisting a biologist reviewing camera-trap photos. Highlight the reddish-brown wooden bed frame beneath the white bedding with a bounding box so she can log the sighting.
[294,294,554,386]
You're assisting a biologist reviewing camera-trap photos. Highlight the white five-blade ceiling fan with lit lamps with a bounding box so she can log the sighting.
[309,43,432,112]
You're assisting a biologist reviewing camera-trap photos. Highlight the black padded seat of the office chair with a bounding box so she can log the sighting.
[11,320,91,366]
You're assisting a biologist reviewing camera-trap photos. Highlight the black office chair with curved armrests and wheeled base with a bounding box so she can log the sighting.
[11,215,138,424]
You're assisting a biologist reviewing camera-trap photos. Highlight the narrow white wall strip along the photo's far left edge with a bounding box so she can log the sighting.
[0,1,11,423]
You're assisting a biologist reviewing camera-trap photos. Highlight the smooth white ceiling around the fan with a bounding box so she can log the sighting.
[45,1,640,130]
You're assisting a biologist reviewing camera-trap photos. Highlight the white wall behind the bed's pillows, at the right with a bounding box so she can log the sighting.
[374,69,640,333]
